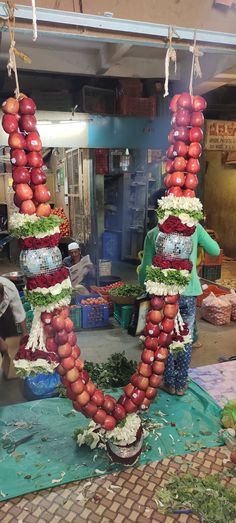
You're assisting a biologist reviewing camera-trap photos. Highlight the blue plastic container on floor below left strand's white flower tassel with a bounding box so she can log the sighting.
[23,371,61,401]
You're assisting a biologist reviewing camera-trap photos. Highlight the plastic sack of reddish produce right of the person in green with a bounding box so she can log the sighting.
[202,293,232,325]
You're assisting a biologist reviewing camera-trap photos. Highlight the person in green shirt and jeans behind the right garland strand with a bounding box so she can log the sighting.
[138,224,220,396]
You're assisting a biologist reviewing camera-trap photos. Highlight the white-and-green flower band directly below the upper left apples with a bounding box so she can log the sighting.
[10,214,61,239]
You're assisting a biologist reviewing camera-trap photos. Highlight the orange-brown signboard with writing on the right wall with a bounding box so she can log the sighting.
[205,120,236,151]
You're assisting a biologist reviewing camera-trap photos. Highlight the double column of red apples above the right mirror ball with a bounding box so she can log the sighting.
[164,93,207,198]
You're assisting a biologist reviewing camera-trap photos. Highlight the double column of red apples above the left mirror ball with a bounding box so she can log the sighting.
[2,95,51,216]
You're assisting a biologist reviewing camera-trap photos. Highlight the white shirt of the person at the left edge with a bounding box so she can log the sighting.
[0,276,25,323]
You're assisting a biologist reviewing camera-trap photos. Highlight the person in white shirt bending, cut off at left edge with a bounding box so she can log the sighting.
[0,276,27,352]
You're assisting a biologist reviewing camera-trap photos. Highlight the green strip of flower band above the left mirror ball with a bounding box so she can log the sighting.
[11,215,62,238]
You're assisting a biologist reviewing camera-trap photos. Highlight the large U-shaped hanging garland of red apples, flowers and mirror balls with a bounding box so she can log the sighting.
[3,93,206,442]
